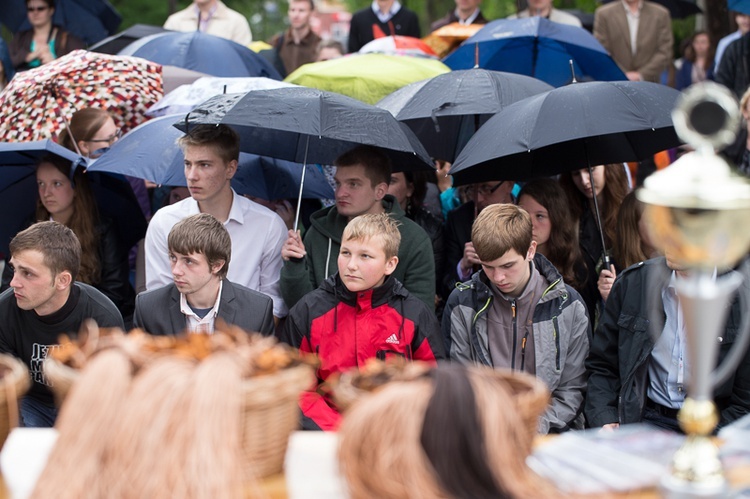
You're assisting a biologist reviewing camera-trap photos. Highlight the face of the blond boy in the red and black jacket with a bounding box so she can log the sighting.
[338,237,398,293]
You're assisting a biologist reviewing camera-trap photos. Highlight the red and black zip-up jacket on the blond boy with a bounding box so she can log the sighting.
[278,274,445,430]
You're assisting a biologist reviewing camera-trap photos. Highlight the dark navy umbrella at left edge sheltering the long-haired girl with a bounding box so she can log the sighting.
[0,140,146,255]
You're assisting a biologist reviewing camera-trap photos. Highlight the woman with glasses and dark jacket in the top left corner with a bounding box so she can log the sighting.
[10,0,86,71]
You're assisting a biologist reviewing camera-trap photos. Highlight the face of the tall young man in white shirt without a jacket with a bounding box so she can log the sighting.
[185,145,237,203]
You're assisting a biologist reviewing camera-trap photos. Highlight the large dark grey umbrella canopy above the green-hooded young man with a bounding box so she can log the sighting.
[175,87,433,171]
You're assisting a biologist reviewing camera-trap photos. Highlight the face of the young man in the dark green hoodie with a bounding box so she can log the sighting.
[333,165,388,218]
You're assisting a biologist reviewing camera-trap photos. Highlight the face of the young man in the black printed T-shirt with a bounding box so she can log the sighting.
[10,250,71,316]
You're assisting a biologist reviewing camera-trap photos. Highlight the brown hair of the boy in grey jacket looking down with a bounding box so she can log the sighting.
[471,203,532,262]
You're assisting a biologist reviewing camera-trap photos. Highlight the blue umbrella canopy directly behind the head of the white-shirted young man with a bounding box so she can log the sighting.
[88,115,333,200]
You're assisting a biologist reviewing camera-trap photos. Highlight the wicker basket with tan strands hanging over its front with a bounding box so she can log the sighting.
[44,358,315,478]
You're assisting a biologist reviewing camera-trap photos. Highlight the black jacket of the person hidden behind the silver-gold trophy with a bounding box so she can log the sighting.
[584,258,750,427]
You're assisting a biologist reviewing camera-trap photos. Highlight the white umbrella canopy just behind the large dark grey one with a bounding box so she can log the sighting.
[146,76,293,116]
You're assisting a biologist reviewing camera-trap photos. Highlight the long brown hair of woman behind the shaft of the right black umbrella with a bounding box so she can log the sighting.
[560,163,629,250]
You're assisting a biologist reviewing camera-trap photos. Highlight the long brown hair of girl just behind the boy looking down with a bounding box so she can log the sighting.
[518,178,583,287]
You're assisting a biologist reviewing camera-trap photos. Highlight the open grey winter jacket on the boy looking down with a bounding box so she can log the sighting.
[442,254,591,433]
